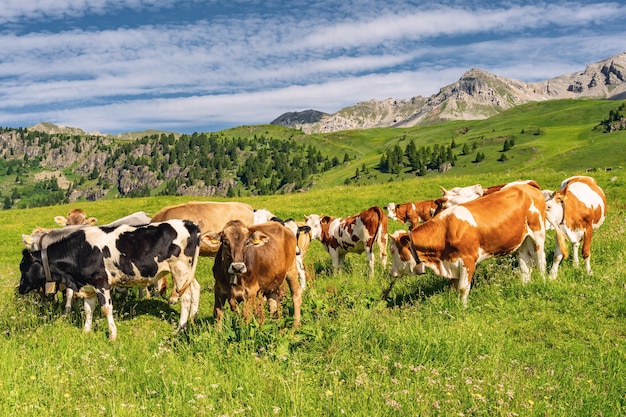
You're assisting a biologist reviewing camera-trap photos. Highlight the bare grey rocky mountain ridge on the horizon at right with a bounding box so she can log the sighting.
[271,52,626,133]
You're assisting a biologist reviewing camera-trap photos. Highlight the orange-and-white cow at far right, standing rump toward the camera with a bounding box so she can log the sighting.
[544,176,606,278]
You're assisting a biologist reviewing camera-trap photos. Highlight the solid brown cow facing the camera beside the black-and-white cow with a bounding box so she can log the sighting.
[212,220,302,327]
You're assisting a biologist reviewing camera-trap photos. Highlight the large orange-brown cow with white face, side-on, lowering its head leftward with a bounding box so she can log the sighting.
[391,183,564,304]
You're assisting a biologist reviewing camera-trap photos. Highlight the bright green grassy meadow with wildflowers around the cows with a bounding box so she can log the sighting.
[0,165,626,417]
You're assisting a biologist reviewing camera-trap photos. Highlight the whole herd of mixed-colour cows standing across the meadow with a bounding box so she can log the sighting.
[18,176,606,340]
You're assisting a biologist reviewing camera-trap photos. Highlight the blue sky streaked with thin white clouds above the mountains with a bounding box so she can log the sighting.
[0,0,626,133]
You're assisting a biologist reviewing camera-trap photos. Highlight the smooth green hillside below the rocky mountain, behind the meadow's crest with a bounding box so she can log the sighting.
[300,100,626,187]
